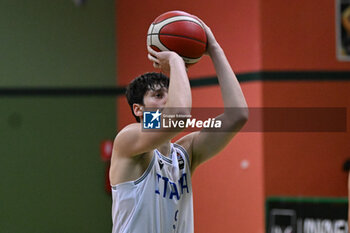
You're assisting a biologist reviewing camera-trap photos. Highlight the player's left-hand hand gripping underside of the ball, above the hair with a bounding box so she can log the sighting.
[147,46,182,73]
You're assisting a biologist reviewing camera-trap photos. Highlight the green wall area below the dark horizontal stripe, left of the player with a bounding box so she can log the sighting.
[0,97,115,233]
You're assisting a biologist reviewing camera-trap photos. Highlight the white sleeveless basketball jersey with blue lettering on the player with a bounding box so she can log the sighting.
[112,144,194,233]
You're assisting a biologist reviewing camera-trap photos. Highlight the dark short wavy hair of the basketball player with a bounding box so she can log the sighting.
[125,72,169,122]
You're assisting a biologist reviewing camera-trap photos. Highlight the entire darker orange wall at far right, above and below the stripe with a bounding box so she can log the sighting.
[261,0,350,196]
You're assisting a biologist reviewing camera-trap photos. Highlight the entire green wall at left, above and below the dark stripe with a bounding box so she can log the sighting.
[0,0,116,233]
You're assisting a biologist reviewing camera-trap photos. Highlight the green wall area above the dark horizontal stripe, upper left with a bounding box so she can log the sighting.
[0,0,116,87]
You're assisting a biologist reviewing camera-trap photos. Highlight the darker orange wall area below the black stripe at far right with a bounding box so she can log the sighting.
[263,81,350,196]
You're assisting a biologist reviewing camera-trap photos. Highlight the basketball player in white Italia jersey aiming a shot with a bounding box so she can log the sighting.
[110,18,248,233]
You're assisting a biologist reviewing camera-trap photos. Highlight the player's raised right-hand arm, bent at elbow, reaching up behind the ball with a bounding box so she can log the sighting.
[180,19,248,171]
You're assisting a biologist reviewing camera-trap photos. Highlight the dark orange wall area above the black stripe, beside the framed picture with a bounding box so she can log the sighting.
[261,0,350,71]
